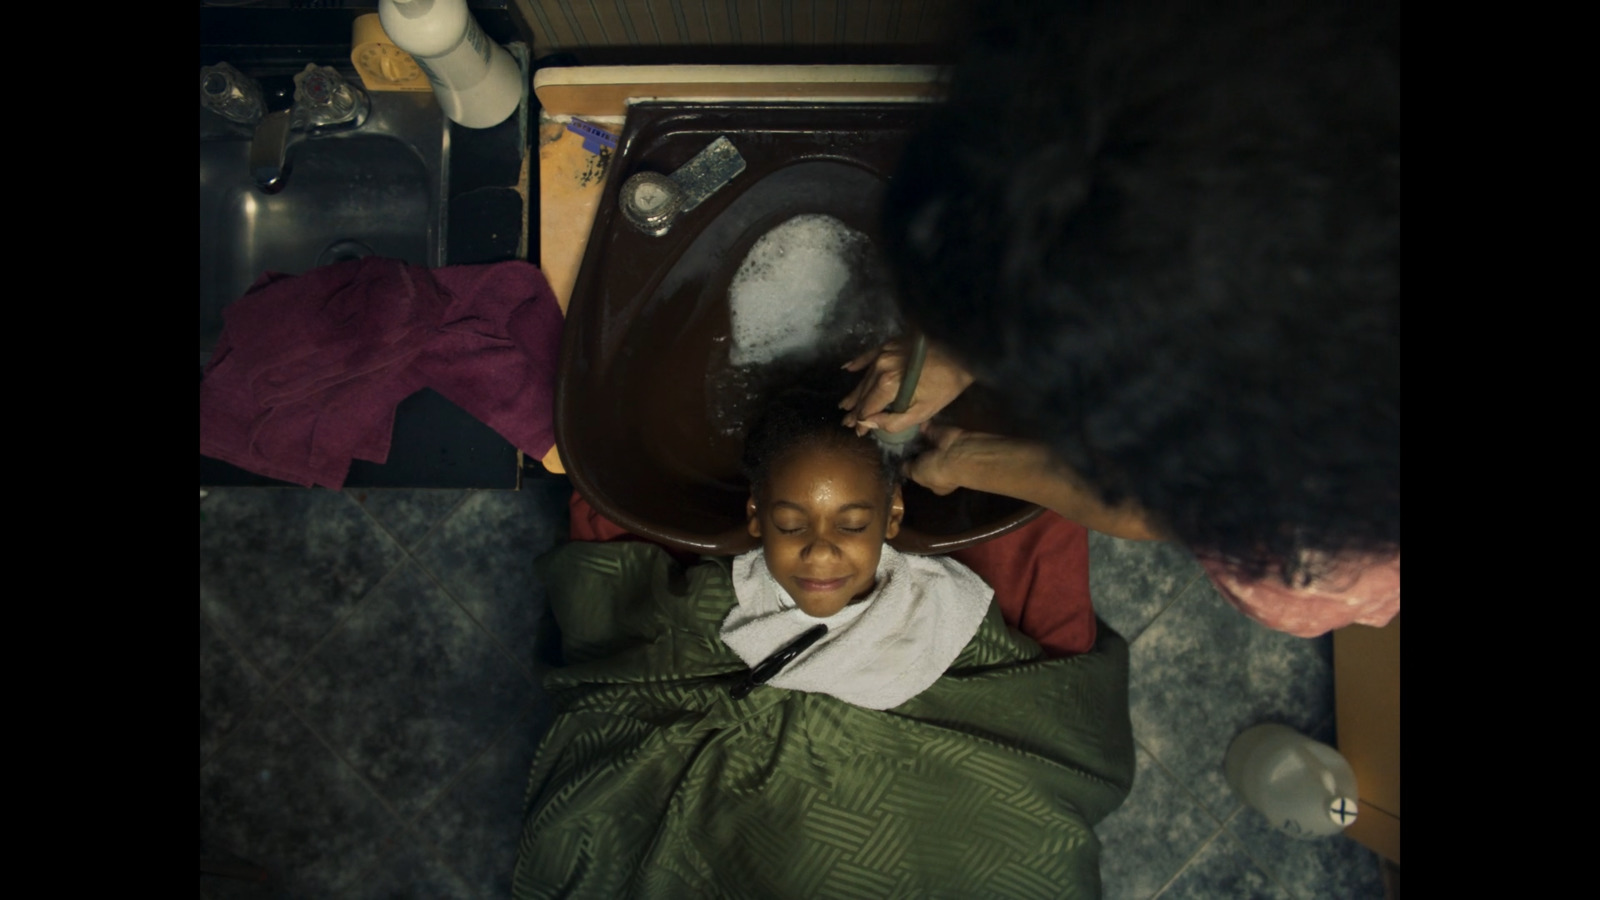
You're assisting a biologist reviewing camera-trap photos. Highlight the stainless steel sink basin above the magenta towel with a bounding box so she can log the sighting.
[200,93,450,365]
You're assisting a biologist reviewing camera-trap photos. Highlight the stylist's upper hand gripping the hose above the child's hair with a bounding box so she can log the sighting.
[838,341,973,436]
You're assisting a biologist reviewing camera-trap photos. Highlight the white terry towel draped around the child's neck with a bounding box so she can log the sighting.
[722,544,994,709]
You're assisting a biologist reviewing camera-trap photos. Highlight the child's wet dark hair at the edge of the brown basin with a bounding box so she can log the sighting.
[741,370,901,496]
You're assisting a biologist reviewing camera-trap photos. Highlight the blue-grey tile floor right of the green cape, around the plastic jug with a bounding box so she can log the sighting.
[1090,535,1384,900]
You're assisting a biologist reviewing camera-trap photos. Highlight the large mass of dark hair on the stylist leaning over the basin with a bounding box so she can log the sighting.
[885,0,1400,578]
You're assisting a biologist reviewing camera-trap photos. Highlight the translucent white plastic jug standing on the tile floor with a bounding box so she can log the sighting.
[1222,724,1357,841]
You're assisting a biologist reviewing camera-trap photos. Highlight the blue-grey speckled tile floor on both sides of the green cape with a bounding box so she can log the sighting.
[200,477,1382,900]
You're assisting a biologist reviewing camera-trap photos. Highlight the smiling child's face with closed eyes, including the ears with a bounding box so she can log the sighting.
[746,448,906,618]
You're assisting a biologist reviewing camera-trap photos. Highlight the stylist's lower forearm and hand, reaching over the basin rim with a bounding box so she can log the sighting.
[906,424,1162,541]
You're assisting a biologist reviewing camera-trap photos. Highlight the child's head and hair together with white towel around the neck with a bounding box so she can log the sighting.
[722,381,994,709]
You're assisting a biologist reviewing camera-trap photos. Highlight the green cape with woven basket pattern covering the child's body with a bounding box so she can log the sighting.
[515,543,1133,900]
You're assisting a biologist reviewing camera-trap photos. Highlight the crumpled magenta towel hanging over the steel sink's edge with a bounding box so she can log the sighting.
[200,256,562,488]
